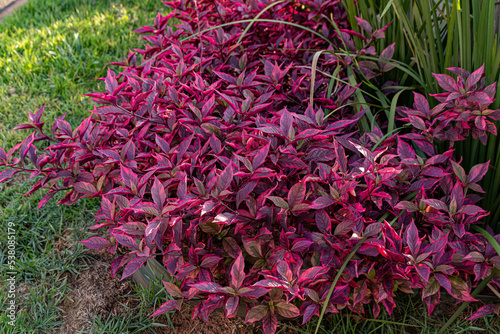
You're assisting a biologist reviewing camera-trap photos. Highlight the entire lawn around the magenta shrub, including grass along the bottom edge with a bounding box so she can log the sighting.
[0,0,500,334]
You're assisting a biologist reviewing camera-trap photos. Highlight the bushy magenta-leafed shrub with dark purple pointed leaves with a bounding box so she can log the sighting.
[0,0,500,334]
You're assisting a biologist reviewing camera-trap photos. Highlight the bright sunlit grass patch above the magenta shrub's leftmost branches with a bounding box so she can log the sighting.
[0,0,159,145]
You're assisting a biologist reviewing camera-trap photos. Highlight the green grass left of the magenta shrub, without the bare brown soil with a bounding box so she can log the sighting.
[0,0,172,334]
